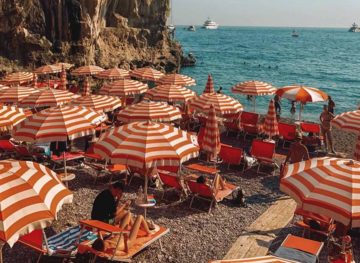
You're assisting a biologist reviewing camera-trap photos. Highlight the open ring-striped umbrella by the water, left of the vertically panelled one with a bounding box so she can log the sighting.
[231,80,276,96]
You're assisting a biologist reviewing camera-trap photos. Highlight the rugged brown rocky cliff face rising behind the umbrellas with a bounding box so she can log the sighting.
[0,0,181,71]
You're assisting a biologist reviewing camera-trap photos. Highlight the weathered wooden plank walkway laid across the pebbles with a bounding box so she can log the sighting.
[224,197,296,259]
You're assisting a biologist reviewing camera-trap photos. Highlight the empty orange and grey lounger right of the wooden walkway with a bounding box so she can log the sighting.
[274,234,324,263]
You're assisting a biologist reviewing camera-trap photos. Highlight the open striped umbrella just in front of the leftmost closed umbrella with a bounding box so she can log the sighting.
[18,89,74,108]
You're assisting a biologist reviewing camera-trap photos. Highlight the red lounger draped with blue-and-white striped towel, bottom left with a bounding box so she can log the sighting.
[19,226,97,262]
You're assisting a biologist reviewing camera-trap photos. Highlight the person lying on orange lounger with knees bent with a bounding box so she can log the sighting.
[92,215,154,255]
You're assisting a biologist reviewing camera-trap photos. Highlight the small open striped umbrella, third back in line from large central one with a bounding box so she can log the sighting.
[99,79,148,97]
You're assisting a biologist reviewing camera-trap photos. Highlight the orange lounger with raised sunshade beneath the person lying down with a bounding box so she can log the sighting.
[78,220,170,262]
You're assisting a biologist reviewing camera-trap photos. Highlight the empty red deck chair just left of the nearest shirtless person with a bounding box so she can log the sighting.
[250,139,277,175]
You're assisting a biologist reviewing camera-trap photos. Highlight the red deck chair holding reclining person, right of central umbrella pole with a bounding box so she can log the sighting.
[187,181,237,213]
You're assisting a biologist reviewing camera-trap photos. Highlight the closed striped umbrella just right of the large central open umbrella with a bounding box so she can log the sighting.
[200,105,221,158]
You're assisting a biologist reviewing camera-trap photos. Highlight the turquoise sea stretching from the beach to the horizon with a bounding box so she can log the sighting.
[175,26,360,120]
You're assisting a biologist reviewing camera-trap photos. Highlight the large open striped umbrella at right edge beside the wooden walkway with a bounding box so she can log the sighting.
[280,157,360,227]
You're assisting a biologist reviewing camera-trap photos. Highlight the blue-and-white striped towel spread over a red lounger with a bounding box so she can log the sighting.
[47,226,97,255]
